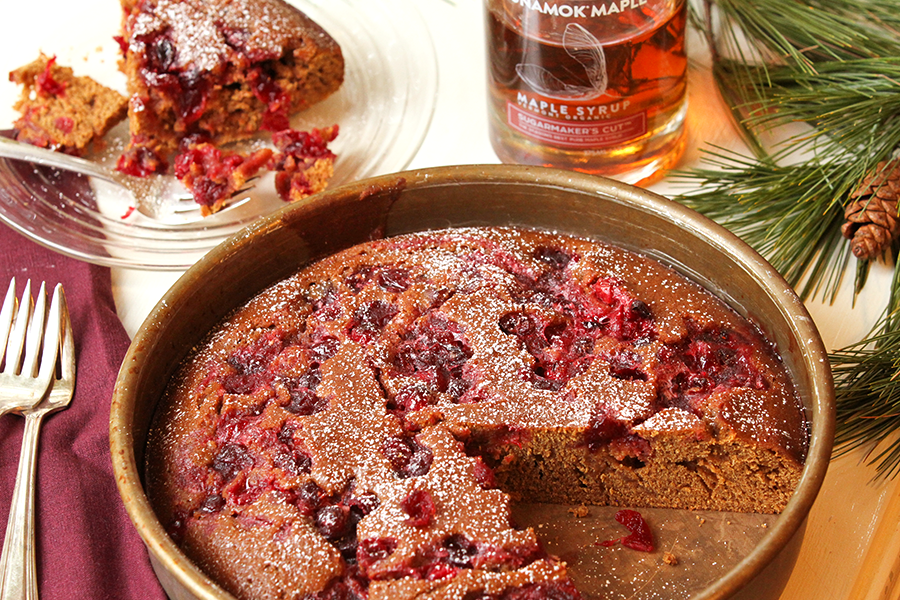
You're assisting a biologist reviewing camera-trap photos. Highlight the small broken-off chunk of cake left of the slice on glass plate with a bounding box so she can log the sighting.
[9,54,128,156]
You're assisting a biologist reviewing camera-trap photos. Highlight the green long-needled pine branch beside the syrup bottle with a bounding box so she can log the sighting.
[675,0,900,477]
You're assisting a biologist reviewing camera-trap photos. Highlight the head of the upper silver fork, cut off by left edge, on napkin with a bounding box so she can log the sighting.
[0,277,60,415]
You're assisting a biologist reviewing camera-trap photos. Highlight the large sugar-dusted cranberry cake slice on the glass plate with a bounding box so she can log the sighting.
[120,0,344,174]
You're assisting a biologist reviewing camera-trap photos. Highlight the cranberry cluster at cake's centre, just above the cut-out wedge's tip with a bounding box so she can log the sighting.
[393,312,472,399]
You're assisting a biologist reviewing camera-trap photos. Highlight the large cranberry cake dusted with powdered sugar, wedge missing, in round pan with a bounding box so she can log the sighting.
[147,228,808,600]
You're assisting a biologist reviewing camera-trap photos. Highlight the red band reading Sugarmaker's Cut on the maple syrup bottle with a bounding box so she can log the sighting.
[506,102,647,150]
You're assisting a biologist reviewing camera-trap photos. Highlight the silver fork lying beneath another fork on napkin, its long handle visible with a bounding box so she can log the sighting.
[0,285,75,600]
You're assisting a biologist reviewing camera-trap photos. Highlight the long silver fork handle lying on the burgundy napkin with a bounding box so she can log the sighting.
[0,414,42,600]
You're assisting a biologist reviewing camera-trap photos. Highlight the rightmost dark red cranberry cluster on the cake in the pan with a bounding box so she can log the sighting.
[657,319,769,414]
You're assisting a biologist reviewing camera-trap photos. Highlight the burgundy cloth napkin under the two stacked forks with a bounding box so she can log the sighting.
[0,225,165,600]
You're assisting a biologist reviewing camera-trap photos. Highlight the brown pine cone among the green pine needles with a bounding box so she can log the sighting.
[841,159,900,260]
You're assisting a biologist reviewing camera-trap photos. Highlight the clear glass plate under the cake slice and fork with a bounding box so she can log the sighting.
[0,0,437,270]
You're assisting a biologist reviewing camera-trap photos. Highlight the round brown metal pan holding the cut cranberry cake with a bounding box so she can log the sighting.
[110,165,834,600]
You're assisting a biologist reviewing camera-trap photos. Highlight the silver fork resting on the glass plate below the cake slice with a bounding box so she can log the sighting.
[0,136,250,223]
